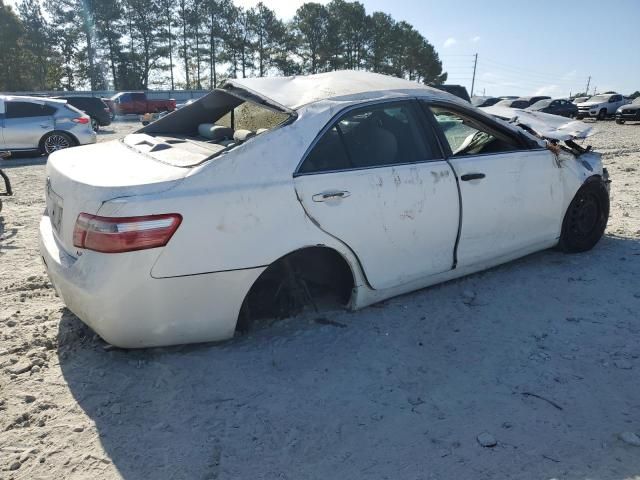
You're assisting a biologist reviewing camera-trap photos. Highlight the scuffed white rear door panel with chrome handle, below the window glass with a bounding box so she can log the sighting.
[295,161,459,289]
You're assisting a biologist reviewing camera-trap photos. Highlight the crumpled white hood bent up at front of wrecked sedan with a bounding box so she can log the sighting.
[482,106,593,141]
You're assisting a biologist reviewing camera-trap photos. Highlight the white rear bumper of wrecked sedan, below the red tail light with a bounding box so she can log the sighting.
[40,215,264,348]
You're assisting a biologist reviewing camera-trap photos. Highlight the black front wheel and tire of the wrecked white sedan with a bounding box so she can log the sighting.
[558,179,609,253]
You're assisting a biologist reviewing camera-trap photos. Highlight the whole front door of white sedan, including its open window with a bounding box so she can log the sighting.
[428,104,564,267]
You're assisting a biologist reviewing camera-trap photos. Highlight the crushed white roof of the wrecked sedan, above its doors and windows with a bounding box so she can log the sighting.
[225,70,451,110]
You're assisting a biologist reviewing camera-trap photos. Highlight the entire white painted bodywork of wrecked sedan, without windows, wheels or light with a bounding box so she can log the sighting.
[40,72,602,347]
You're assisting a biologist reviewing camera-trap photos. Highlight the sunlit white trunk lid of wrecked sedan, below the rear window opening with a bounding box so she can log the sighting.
[46,141,190,256]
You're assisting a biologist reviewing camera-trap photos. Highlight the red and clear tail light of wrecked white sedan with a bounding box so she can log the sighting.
[73,213,182,253]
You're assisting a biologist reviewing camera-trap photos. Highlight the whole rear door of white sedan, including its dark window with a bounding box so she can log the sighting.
[294,100,459,289]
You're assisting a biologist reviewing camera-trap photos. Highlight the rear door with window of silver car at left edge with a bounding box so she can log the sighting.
[3,100,56,150]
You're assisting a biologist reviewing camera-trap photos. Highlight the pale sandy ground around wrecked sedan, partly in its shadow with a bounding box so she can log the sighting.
[0,117,640,480]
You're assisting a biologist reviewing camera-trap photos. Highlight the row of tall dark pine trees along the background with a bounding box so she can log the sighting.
[0,0,447,91]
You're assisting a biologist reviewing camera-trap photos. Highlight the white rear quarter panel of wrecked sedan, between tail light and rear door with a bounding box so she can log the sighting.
[99,103,357,278]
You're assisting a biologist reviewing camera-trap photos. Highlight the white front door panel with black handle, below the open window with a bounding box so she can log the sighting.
[450,150,565,267]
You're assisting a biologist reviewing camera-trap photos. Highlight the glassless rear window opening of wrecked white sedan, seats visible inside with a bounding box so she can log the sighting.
[123,90,291,167]
